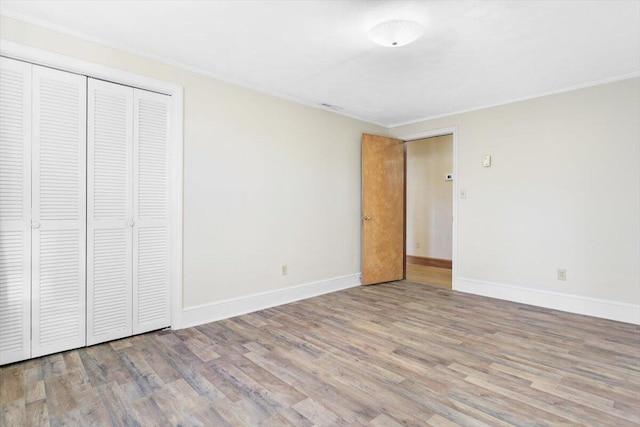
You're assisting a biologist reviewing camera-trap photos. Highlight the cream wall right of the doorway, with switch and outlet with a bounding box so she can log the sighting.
[391,78,640,304]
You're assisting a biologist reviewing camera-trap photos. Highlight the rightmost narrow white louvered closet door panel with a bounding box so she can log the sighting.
[133,89,170,334]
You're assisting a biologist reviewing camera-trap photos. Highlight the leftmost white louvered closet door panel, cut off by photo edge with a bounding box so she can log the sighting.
[0,58,31,365]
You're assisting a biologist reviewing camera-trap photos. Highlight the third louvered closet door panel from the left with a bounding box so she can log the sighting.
[87,79,133,345]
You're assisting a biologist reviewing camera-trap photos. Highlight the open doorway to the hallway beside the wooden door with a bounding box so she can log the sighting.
[405,134,454,289]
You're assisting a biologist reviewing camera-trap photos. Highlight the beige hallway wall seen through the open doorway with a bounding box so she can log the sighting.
[407,135,453,259]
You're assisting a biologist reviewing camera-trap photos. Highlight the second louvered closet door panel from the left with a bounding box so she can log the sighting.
[31,65,86,357]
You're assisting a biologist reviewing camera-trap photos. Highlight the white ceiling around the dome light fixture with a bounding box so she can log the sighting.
[0,0,640,126]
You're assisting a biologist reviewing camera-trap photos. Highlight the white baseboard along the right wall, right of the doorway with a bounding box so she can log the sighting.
[453,277,640,325]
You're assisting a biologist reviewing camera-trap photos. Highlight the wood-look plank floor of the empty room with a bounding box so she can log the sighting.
[0,282,640,426]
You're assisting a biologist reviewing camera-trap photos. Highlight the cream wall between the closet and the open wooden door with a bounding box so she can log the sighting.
[0,17,387,307]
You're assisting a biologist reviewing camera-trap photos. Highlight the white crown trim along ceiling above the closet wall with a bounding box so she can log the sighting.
[1,11,389,128]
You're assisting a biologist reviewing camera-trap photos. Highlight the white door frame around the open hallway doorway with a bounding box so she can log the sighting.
[394,126,460,290]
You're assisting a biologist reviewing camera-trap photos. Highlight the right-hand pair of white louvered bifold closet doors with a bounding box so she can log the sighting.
[87,79,170,345]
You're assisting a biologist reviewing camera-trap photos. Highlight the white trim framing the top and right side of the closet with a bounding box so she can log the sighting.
[0,40,184,329]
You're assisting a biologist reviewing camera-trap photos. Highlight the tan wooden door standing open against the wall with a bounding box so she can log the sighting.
[362,134,405,285]
